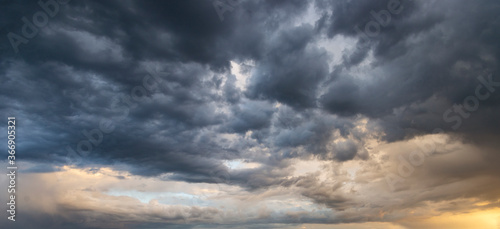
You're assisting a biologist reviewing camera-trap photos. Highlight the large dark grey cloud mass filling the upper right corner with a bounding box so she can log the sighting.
[320,1,500,139]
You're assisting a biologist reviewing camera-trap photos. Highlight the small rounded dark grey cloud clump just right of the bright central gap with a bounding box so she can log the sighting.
[247,25,328,108]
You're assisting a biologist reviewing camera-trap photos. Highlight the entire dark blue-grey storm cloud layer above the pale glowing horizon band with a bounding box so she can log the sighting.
[0,0,500,224]
